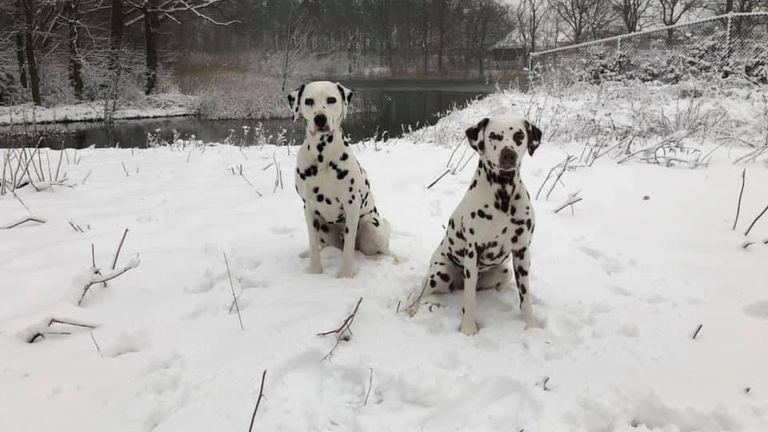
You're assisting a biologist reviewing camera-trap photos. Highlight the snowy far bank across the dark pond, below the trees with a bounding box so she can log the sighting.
[0,93,197,126]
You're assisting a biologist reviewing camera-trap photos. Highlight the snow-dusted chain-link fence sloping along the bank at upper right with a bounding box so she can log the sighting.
[529,12,768,85]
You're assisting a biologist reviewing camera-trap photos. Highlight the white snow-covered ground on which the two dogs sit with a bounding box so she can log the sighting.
[0,82,768,432]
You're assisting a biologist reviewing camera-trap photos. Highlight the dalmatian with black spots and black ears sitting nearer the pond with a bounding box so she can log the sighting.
[288,81,390,278]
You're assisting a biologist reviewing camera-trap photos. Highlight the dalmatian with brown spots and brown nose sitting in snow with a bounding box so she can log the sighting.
[408,117,541,335]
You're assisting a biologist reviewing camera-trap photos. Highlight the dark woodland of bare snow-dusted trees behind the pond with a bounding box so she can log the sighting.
[0,0,768,120]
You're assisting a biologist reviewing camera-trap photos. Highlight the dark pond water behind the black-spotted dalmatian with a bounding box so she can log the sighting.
[0,79,493,148]
